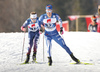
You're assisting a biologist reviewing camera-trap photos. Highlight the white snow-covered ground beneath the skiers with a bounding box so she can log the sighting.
[0,32,100,72]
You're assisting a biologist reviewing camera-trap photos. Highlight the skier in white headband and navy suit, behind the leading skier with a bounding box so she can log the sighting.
[21,12,40,63]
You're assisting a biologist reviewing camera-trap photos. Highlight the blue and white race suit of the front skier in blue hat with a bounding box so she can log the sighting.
[39,13,72,57]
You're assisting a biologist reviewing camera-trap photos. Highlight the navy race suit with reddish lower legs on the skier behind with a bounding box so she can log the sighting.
[22,18,40,55]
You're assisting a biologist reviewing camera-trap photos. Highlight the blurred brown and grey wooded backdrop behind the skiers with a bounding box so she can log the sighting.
[0,0,100,32]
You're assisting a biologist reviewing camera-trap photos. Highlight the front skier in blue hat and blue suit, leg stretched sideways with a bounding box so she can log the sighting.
[39,4,80,65]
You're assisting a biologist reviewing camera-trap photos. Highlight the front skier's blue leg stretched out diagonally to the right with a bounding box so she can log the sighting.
[53,34,80,63]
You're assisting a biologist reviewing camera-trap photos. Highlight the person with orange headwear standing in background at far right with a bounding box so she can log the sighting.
[88,15,97,32]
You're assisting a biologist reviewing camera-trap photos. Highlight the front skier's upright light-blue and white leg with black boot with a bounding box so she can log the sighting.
[45,36,52,66]
